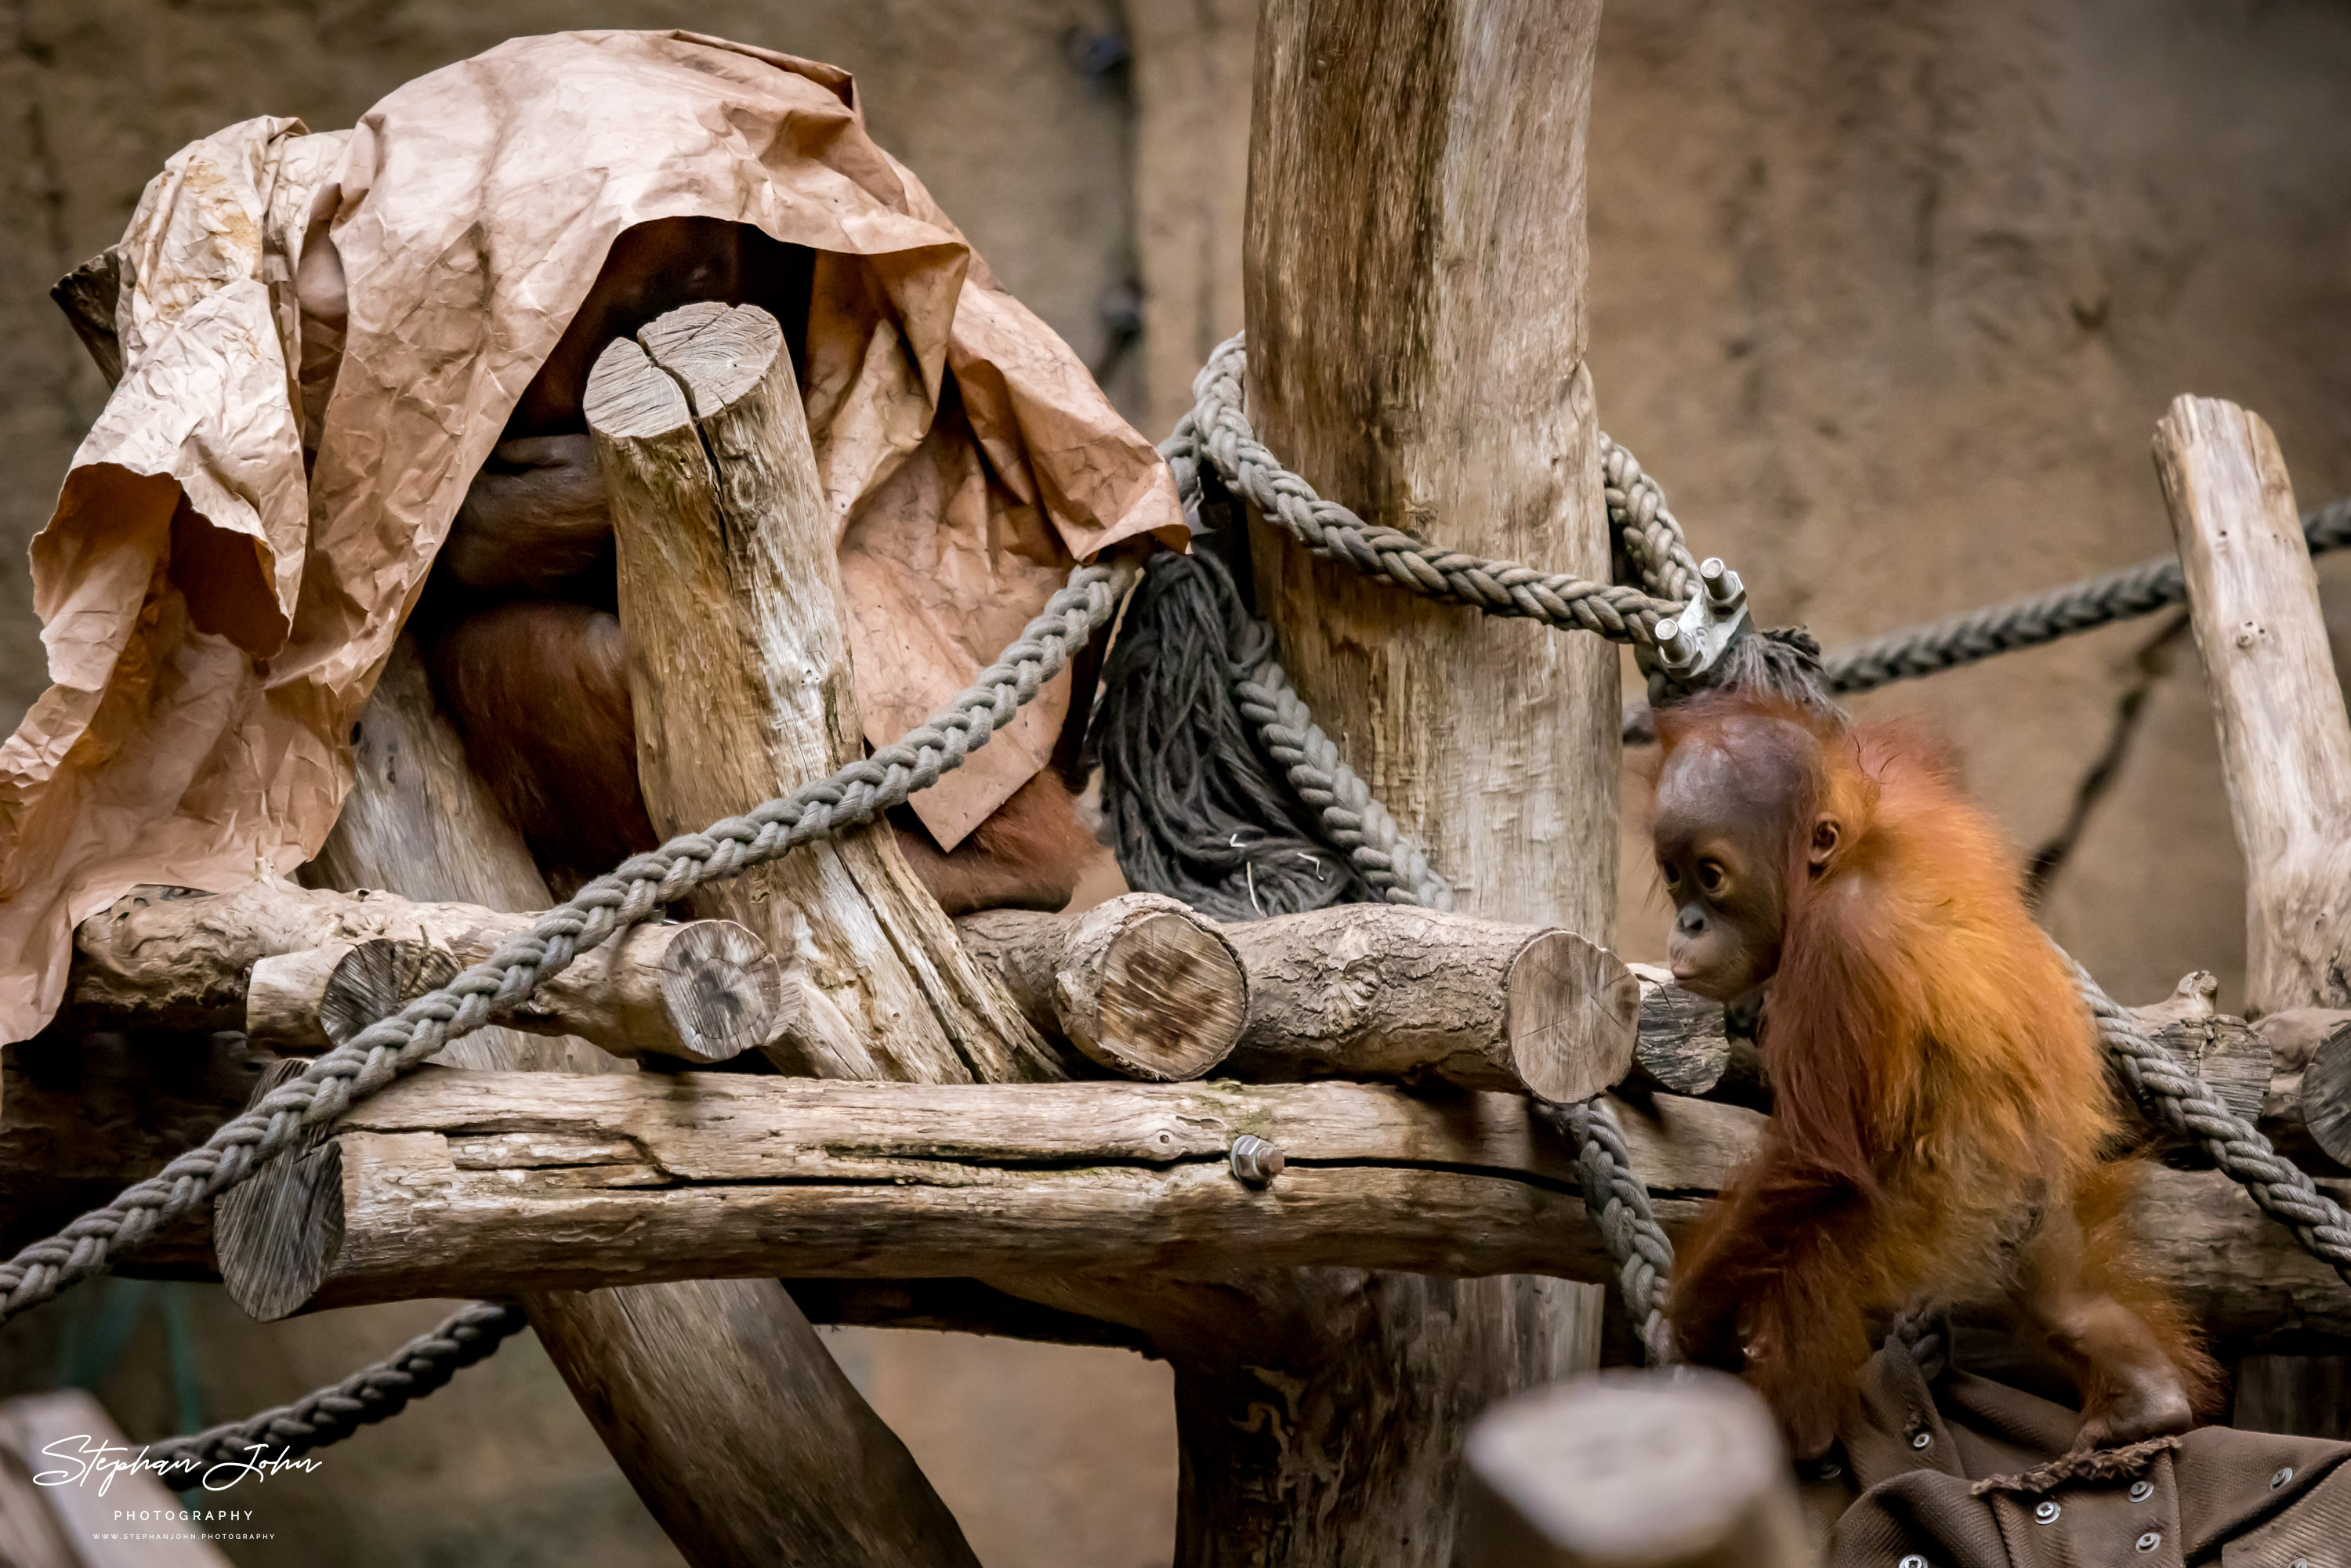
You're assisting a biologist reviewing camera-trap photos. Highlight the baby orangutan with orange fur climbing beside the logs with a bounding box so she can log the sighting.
[1655,693,2215,1455]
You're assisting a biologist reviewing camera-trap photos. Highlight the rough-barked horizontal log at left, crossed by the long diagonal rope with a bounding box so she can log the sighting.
[68,882,781,1063]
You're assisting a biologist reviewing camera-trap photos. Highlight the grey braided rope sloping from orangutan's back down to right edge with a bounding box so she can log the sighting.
[2067,959,2351,1284]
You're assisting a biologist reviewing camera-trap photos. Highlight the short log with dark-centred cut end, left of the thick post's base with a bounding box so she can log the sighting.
[955,893,1248,1081]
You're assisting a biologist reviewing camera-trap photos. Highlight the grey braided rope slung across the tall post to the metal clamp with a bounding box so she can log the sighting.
[1168,334,1697,646]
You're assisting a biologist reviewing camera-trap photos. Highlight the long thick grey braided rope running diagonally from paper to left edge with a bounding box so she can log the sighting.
[0,564,1133,1324]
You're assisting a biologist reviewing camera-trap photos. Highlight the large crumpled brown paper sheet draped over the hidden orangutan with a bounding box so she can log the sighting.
[0,31,1185,1039]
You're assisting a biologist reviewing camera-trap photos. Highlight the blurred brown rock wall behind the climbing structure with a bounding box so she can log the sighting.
[0,0,2351,1568]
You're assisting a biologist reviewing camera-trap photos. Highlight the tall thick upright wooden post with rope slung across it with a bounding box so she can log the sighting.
[1171,0,1617,1568]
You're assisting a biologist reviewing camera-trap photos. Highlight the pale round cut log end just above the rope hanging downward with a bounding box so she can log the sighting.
[1505,931,1641,1103]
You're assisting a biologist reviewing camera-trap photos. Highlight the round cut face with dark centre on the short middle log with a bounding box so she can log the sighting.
[1056,912,1248,1084]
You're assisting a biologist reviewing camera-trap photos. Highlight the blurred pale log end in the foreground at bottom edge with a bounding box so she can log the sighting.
[1460,1371,1820,1568]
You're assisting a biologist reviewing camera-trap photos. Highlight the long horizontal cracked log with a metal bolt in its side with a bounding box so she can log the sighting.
[197,1070,2351,1338]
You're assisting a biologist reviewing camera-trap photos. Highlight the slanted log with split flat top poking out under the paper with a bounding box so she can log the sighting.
[585,306,1063,1081]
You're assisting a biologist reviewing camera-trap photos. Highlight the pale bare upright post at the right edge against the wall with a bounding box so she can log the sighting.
[2156,397,2351,1013]
